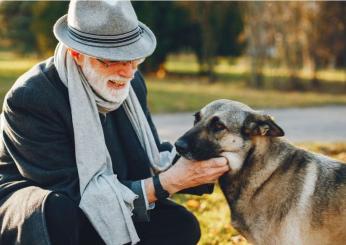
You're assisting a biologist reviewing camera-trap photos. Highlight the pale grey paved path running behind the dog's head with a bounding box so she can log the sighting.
[153,106,346,142]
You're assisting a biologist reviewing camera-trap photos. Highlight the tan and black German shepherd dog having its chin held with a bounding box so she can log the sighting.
[175,100,346,245]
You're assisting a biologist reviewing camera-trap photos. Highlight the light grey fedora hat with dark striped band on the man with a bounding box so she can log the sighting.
[53,0,156,61]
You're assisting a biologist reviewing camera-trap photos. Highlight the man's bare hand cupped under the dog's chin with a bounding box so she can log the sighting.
[160,157,229,194]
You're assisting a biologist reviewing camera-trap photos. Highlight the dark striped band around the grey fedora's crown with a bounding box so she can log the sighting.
[67,26,144,47]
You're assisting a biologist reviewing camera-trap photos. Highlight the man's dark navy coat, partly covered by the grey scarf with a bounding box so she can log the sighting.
[0,58,171,245]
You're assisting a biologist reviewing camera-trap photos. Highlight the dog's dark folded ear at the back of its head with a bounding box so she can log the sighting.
[242,114,285,137]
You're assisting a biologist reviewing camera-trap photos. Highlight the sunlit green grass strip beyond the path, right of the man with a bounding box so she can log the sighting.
[151,55,346,113]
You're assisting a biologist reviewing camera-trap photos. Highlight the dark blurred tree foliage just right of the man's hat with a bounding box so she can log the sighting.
[133,2,244,77]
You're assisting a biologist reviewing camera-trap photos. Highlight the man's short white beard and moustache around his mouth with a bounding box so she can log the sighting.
[81,57,133,104]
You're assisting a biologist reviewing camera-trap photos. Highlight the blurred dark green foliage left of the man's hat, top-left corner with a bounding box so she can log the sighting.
[0,1,68,56]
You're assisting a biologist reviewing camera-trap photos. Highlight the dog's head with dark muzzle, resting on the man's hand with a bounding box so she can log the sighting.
[175,99,284,172]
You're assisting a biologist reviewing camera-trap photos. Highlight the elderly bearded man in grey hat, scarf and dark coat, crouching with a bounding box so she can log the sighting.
[0,1,228,245]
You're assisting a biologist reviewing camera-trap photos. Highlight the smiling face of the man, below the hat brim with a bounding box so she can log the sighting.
[76,54,140,103]
